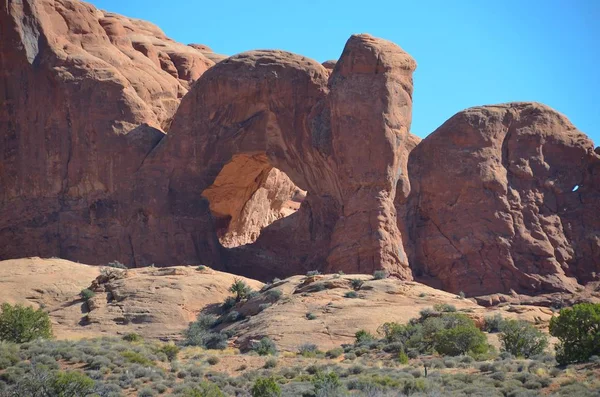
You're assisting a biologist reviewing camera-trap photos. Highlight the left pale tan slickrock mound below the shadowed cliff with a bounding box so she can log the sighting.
[0,258,262,339]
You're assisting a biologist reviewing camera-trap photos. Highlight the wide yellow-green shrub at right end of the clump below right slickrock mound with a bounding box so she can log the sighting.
[434,324,488,356]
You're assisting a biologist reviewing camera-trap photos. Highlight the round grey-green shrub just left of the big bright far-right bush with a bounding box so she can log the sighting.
[500,320,548,358]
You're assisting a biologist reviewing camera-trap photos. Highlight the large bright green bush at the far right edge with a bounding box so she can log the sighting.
[550,303,600,365]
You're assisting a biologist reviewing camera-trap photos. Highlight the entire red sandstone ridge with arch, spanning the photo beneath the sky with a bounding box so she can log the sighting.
[0,0,600,295]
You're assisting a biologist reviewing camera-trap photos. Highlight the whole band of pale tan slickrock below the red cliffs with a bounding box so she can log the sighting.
[5,258,600,351]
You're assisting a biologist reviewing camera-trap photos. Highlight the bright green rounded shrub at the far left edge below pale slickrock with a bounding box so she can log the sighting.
[0,303,52,343]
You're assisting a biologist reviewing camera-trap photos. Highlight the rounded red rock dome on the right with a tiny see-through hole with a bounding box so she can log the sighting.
[407,103,600,295]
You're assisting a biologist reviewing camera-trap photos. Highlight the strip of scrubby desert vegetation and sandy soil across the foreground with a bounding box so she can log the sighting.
[0,296,600,397]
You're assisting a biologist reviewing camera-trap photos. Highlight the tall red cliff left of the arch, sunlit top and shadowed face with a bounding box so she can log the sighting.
[0,0,220,265]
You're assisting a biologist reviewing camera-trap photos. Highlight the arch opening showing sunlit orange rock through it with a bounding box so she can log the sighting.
[202,153,307,248]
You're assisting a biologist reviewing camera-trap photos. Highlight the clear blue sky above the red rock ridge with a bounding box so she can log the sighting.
[86,0,600,145]
